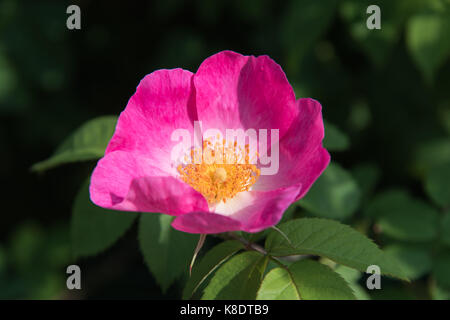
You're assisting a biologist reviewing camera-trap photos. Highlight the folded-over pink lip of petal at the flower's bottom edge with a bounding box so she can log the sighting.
[172,212,242,234]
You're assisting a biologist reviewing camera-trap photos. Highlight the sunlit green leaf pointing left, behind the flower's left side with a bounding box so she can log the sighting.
[31,116,117,171]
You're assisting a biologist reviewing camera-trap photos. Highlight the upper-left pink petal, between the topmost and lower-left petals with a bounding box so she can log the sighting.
[105,69,197,174]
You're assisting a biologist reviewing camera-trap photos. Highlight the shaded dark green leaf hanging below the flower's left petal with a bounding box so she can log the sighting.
[71,180,137,256]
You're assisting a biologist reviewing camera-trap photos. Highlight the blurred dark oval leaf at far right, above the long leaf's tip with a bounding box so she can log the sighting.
[366,189,439,242]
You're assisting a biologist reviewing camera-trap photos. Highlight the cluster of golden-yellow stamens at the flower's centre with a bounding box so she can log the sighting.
[177,140,260,204]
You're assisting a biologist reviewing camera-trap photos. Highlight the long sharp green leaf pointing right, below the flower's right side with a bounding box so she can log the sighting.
[266,218,407,280]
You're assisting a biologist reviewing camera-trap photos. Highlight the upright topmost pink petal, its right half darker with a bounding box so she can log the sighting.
[194,51,298,137]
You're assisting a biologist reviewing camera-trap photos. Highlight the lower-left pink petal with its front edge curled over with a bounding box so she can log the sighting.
[90,151,208,215]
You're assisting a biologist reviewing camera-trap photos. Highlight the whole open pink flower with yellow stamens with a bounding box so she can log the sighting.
[90,51,330,234]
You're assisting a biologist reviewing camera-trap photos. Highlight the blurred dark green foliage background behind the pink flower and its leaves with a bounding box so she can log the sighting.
[0,0,450,299]
